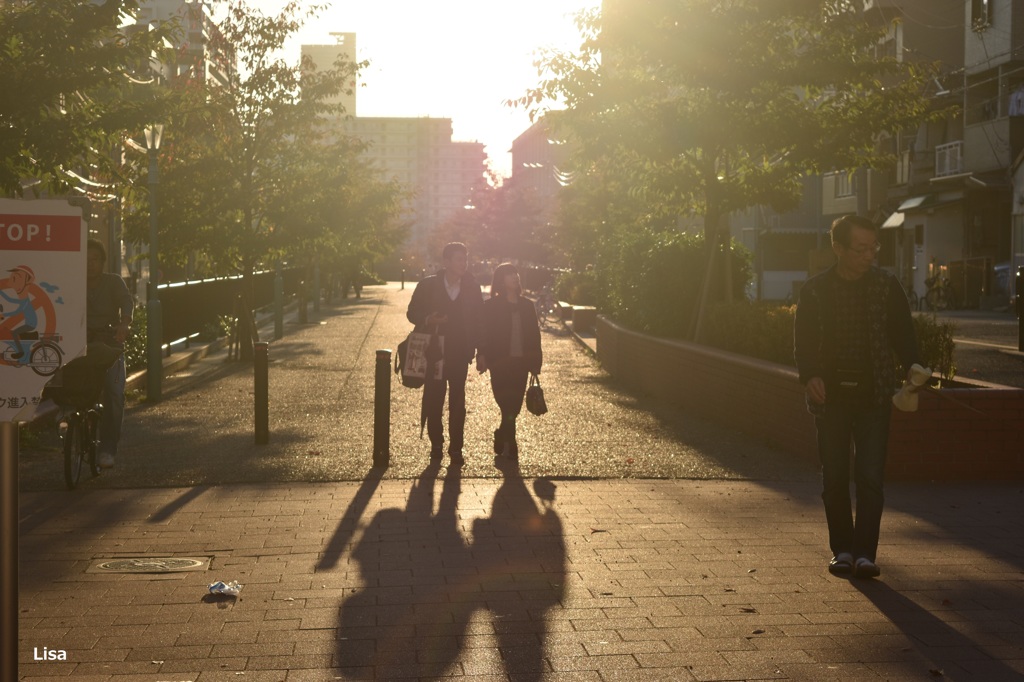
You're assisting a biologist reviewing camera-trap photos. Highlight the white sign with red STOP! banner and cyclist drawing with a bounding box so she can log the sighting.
[0,199,86,422]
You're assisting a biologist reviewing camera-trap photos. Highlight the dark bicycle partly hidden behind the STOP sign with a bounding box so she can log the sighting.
[43,343,121,491]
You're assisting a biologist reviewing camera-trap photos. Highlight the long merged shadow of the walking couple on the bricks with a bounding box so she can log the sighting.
[335,464,565,680]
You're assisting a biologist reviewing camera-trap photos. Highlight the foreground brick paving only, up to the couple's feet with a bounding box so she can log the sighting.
[19,475,1024,682]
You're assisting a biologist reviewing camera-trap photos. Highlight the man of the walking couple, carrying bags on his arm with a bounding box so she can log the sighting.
[406,242,483,466]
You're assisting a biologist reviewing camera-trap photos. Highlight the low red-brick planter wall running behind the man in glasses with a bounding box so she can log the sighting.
[597,315,1024,480]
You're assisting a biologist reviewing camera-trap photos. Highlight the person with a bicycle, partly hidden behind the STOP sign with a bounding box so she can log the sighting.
[85,240,135,469]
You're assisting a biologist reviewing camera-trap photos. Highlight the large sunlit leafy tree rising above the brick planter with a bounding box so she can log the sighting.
[519,0,931,335]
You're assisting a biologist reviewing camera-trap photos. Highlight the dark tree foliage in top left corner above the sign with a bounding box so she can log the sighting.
[0,0,171,197]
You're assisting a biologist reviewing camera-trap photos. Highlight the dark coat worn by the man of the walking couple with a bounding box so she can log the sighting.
[406,270,483,364]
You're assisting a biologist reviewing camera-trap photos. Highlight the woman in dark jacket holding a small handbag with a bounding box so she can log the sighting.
[476,263,543,460]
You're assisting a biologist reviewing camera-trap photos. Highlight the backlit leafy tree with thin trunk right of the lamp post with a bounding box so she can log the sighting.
[118,1,393,356]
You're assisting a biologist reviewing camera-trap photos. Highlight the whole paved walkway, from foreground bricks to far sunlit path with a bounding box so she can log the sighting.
[14,286,1024,682]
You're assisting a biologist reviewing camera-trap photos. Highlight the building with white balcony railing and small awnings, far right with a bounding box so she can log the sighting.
[883,0,1024,308]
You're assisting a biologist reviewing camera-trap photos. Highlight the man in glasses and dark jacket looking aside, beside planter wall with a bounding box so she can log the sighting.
[794,215,920,578]
